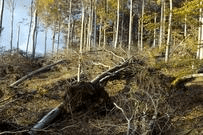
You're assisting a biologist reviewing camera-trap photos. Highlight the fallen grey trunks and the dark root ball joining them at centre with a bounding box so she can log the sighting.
[30,57,140,135]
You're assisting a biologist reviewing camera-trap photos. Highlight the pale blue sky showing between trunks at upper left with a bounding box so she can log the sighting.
[0,0,64,54]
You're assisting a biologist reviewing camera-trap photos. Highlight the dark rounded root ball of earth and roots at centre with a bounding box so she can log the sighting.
[63,82,113,114]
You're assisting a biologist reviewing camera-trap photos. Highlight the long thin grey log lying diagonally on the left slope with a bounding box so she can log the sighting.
[10,60,64,87]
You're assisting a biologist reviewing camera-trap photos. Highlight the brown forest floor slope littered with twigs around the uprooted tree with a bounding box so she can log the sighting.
[0,50,203,135]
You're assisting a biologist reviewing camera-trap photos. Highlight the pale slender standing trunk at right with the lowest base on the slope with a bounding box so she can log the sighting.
[165,0,172,63]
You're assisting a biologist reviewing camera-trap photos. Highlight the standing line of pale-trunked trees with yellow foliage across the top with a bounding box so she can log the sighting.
[0,0,203,62]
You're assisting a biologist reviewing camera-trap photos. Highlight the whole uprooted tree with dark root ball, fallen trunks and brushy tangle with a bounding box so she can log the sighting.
[26,57,182,134]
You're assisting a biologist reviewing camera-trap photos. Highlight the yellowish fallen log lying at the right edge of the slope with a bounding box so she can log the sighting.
[172,73,203,86]
